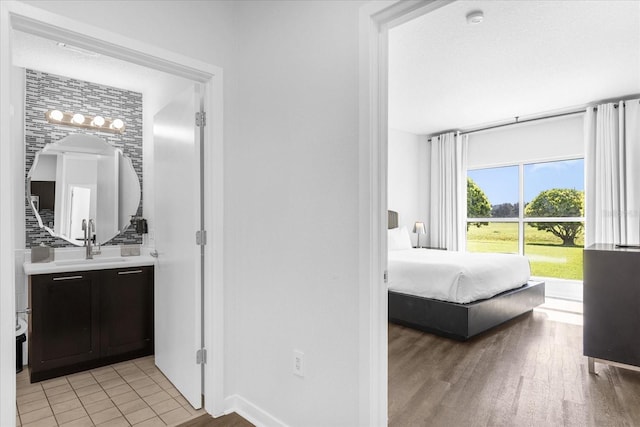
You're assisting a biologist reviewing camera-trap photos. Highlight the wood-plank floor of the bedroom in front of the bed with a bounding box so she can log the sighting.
[389,310,640,427]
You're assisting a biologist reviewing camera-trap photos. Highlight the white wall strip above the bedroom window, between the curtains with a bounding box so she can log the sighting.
[468,114,584,169]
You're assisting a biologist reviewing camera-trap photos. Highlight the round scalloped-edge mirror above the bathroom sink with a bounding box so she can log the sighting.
[27,134,140,246]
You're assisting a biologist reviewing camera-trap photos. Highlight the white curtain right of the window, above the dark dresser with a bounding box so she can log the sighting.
[584,99,640,245]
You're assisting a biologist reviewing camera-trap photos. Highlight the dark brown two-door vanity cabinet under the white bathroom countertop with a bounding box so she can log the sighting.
[29,266,153,382]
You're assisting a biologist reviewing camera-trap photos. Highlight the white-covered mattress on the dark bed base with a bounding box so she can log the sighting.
[388,249,531,304]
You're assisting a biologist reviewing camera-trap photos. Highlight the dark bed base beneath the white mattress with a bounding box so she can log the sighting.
[389,281,544,341]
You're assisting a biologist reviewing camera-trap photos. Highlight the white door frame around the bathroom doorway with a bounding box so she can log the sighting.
[0,1,224,425]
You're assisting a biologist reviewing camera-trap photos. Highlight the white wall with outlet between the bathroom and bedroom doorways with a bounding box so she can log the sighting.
[225,1,370,426]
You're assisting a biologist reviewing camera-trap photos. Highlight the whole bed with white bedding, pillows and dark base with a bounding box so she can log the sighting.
[388,211,545,341]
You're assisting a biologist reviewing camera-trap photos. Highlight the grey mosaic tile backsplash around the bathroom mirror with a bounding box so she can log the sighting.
[25,69,143,248]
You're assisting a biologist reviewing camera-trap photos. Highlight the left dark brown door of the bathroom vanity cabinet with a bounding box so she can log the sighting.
[29,271,100,381]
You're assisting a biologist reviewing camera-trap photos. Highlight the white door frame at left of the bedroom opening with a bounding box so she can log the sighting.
[358,0,452,426]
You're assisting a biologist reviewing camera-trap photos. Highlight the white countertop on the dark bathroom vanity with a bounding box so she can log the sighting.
[22,246,156,276]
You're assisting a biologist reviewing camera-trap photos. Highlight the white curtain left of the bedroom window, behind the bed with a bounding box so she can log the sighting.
[427,132,469,251]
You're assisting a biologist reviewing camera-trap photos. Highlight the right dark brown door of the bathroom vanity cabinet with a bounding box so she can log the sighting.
[100,267,153,357]
